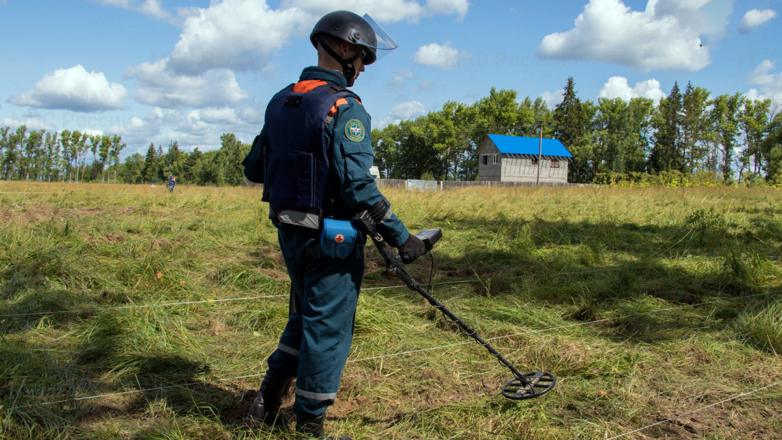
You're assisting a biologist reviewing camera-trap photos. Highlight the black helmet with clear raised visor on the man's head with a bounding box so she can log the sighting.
[310,11,397,65]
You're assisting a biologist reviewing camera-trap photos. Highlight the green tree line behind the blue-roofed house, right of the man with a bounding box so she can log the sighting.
[372,77,782,184]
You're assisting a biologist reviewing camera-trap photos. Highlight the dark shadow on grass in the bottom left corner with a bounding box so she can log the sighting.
[0,306,249,438]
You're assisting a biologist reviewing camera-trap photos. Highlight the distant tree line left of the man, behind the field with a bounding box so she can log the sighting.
[0,125,250,186]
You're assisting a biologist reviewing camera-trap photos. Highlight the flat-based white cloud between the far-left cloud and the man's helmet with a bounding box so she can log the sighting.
[125,58,249,109]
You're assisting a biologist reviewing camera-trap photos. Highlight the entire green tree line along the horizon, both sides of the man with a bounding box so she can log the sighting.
[0,78,782,185]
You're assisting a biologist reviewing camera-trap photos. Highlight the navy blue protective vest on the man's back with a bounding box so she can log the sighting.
[263,84,359,229]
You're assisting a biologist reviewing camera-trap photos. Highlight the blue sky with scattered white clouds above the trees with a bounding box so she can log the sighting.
[0,0,782,155]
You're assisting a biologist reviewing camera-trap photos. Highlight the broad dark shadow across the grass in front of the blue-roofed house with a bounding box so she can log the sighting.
[366,213,782,352]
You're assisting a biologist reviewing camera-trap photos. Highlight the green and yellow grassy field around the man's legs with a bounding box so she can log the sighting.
[0,182,782,439]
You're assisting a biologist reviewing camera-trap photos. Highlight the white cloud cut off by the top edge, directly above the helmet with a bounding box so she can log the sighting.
[280,0,470,21]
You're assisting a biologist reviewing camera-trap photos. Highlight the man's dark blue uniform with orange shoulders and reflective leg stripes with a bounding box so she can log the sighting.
[260,67,410,417]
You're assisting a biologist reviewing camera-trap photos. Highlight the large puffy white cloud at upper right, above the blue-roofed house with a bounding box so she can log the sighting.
[538,0,733,71]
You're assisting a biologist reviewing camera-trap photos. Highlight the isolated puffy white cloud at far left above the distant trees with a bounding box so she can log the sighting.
[8,64,128,112]
